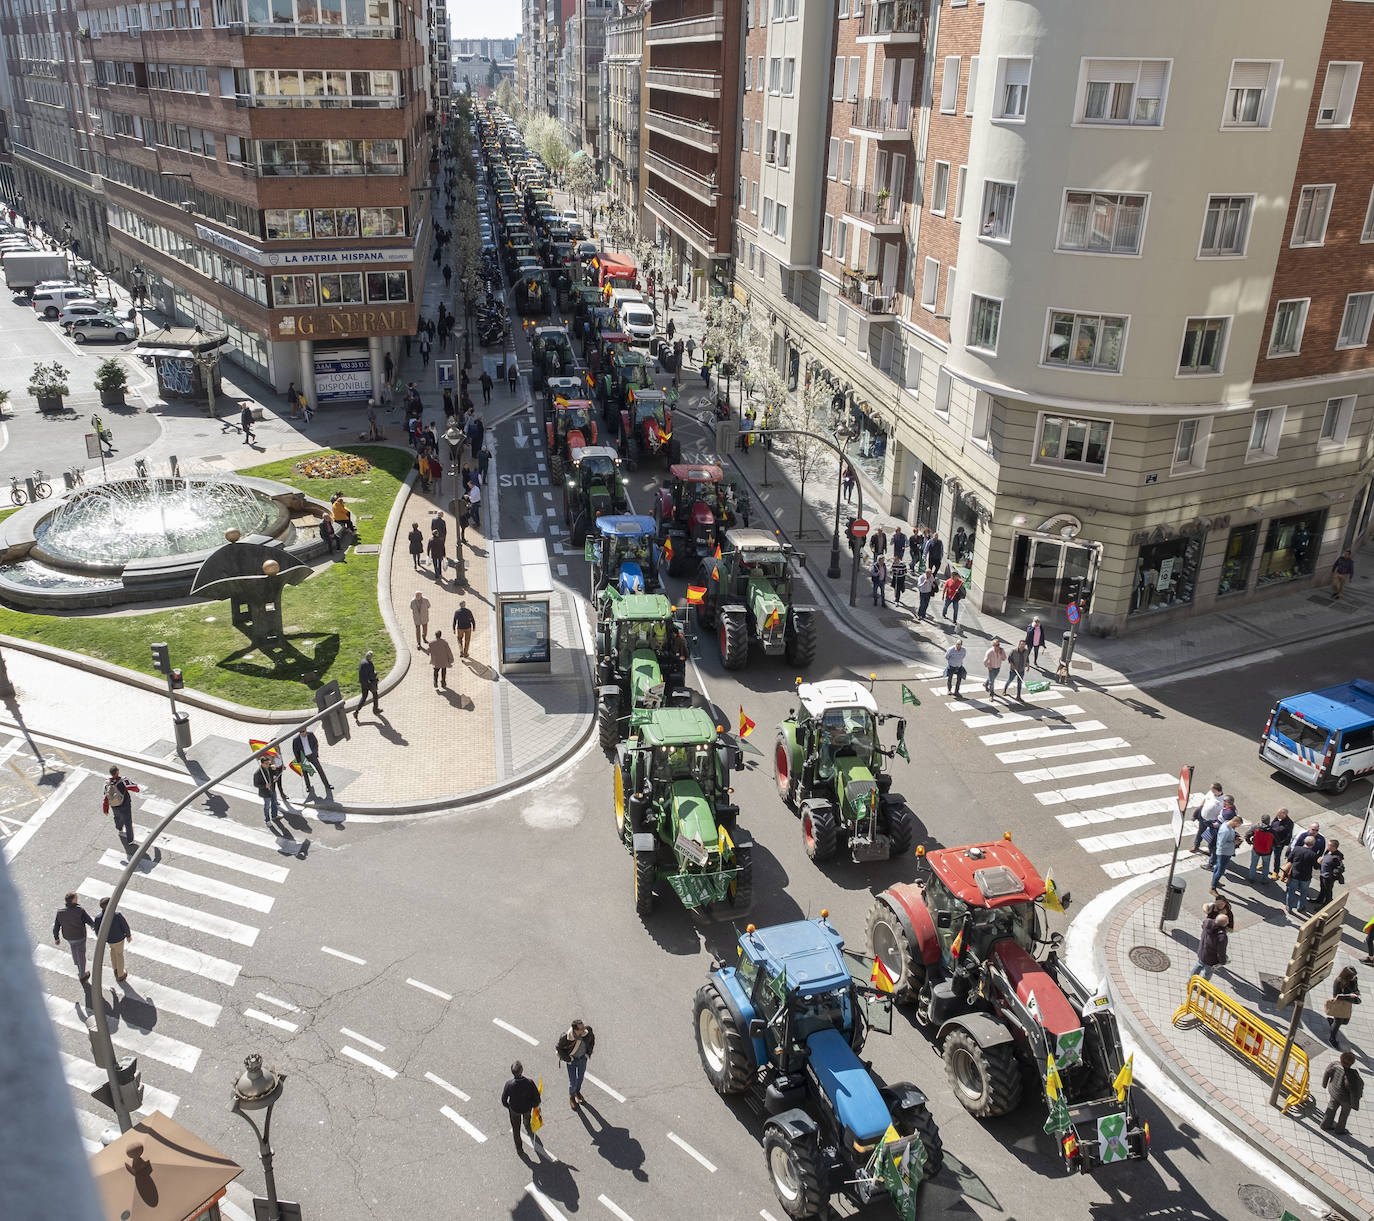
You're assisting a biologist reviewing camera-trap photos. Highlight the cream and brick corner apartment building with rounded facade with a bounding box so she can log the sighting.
[735,0,1374,633]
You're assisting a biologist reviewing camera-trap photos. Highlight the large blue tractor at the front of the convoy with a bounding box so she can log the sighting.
[692,912,944,1218]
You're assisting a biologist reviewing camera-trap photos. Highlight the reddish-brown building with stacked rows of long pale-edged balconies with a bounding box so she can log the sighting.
[642,0,745,301]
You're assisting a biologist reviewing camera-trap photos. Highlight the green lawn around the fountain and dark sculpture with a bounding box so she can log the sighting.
[0,445,411,709]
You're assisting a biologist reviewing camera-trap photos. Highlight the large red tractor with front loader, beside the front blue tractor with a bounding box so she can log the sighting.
[868,836,1150,1173]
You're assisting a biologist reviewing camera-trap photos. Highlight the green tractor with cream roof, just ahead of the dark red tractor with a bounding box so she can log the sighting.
[695,527,816,670]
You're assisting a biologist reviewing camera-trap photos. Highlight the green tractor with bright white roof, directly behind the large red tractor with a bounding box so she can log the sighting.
[774,678,916,863]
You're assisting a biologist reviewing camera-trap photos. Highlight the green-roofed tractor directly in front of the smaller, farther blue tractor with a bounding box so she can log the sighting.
[596,585,692,754]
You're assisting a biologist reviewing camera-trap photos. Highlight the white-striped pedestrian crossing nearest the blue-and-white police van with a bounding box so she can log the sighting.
[929,676,1202,879]
